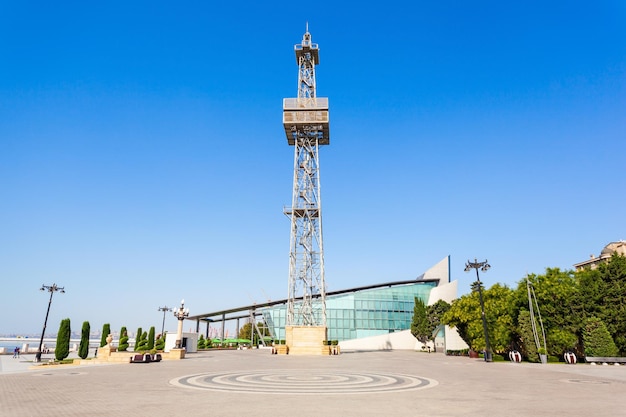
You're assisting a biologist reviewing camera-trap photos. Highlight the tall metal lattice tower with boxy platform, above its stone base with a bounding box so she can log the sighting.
[283,25,330,326]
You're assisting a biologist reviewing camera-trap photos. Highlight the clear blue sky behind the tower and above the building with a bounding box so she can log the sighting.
[0,0,626,334]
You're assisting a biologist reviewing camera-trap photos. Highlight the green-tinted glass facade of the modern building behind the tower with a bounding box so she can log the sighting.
[263,281,437,341]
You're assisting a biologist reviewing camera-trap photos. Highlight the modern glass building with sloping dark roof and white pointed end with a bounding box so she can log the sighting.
[188,257,457,349]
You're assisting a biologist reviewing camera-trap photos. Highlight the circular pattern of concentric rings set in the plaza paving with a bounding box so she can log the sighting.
[170,369,437,395]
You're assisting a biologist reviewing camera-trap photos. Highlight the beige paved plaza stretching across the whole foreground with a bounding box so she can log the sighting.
[0,349,626,417]
